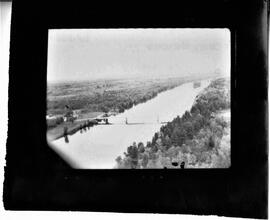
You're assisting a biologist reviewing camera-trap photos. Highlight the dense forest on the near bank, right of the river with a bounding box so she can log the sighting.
[116,78,230,169]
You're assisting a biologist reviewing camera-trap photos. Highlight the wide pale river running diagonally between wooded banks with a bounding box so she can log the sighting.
[50,80,210,169]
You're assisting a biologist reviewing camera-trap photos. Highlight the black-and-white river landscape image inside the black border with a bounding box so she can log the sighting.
[46,28,231,169]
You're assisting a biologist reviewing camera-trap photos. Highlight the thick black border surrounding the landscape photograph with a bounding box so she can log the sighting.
[3,0,268,218]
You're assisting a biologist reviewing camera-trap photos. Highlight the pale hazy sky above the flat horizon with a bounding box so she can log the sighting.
[47,28,230,81]
